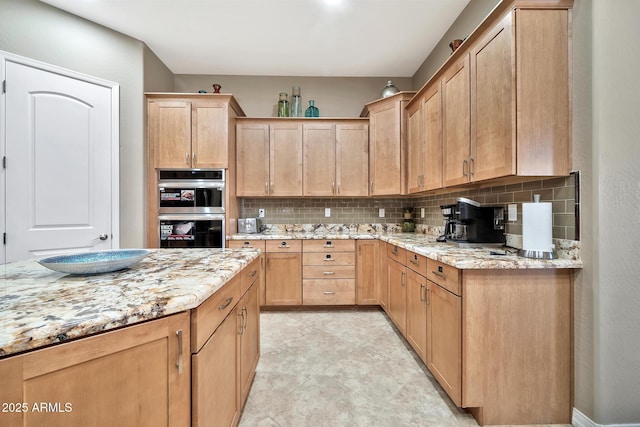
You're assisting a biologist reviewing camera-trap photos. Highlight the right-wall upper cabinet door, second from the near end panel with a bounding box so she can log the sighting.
[442,54,471,187]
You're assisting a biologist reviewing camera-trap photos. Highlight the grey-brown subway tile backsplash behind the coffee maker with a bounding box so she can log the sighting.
[241,176,575,240]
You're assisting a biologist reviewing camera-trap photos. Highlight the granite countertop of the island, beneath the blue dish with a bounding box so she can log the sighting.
[0,249,260,357]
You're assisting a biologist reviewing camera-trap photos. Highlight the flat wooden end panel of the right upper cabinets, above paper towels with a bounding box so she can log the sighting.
[515,9,572,176]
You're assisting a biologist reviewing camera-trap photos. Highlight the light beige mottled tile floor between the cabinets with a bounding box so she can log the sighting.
[239,310,572,427]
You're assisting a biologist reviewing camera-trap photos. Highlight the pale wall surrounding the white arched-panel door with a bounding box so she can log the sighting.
[0,0,145,247]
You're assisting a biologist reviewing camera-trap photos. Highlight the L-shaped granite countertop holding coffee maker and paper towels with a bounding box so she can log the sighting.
[228,225,582,270]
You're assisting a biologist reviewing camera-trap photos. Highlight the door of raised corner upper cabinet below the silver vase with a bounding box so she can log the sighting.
[369,102,401,196]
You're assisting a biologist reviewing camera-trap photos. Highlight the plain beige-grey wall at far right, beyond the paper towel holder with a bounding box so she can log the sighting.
[592,0,640,425]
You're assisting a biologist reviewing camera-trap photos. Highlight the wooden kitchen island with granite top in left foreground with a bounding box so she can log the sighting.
[0,249,262,426]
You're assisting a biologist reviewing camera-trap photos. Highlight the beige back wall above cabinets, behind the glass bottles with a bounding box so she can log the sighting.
[175,74,411,117]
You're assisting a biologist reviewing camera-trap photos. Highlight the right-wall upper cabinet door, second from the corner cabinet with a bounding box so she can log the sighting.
[422,81,442,190]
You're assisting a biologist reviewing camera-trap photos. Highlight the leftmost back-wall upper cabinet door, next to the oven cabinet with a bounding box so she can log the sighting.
[236,124,269,197]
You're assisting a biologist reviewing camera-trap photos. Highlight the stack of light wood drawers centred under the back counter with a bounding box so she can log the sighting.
[302,240,356,305]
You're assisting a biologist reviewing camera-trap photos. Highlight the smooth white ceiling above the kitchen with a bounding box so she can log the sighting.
[41,0,469,77]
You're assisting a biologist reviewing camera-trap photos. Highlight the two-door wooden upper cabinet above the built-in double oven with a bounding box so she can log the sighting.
[146,93,244,169]
